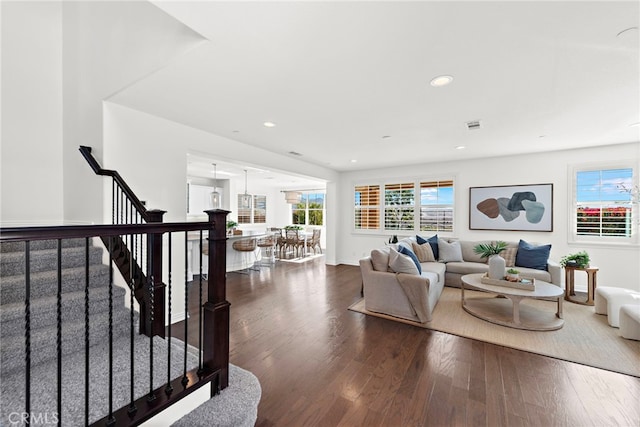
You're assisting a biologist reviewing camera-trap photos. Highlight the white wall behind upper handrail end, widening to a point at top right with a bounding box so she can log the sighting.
[62,1,203,222]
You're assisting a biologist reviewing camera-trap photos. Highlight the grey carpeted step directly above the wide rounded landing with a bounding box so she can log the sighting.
[0,305,131,379]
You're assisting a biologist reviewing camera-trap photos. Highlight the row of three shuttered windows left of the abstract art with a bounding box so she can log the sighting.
[354,179,454,236]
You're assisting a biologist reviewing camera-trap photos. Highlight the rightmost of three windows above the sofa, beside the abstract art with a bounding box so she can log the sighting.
[420,181,453,231]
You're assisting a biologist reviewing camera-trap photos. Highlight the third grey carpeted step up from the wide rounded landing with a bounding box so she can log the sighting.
[0,264,109,304]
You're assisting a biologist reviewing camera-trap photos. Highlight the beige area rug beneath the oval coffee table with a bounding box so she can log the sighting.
[349,287,640,377]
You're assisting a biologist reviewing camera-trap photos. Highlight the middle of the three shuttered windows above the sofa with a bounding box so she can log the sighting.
[384,182,415,230]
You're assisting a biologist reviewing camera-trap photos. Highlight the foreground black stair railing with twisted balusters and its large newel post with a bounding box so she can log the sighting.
[0,210,229,426]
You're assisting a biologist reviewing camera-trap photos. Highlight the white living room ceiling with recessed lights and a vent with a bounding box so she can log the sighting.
[111,1,640,176]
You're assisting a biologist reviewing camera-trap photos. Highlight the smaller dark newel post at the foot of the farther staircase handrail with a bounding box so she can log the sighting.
[140,209,167,338]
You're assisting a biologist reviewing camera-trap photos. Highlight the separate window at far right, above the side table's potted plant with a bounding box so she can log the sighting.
[574,168,634,238]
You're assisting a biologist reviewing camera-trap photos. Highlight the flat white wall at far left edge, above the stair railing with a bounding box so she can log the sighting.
[0,2,63,226]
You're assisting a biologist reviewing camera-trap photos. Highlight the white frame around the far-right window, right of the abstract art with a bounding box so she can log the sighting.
[567,162,640,247]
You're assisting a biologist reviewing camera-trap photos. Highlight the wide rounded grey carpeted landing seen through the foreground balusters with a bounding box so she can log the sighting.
[0,335,198,426]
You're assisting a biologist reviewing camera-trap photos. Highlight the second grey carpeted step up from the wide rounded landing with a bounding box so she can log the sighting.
[0,286,125,339]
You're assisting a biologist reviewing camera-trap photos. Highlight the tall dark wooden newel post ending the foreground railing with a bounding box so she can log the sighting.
[202,209,230,396]
